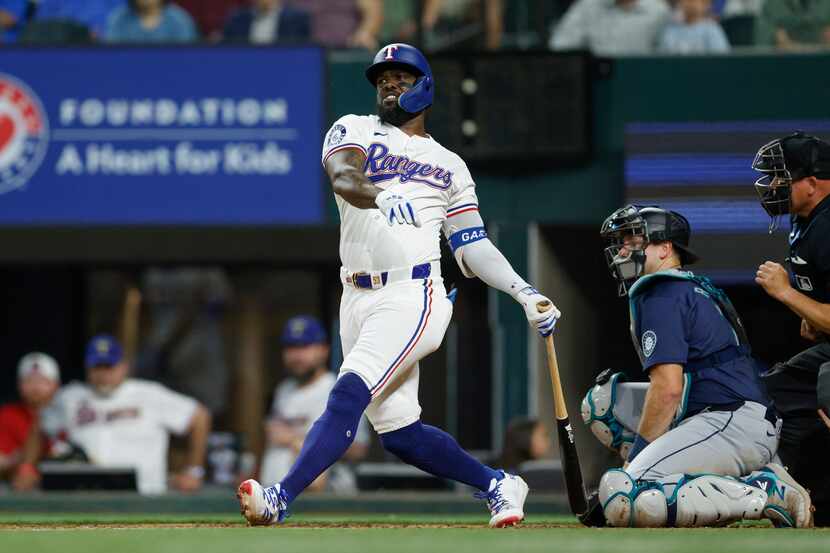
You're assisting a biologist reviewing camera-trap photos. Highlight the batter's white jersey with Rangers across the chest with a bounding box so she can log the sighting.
[323,115,478,271]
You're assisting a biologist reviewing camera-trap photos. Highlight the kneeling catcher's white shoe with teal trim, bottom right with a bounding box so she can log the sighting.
[747,463,813,528]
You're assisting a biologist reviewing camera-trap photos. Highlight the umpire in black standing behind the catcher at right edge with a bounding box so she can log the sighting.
[752,133,830,526]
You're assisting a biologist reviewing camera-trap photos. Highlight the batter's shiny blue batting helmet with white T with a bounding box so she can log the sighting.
[366,43,435,113]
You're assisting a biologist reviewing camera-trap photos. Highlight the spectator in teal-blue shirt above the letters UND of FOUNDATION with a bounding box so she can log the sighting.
[104,0,198,43]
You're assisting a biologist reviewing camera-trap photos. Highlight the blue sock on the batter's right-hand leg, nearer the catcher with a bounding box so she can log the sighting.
[380,421,503,492]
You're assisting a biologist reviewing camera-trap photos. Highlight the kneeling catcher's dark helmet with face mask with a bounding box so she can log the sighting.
[600,205,698,296]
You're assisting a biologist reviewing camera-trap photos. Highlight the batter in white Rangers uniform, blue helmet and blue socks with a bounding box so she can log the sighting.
[237,44,560,527]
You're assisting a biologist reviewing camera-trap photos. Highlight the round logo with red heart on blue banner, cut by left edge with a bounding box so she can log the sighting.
[0,73,49,194]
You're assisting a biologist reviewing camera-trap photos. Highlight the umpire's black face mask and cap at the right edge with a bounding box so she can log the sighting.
[752,132,830,232]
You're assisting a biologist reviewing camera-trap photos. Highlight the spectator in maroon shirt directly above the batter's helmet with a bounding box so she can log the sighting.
[291,0,383,52]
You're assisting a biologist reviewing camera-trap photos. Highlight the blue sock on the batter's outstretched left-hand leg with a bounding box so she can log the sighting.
[281,373,371,503]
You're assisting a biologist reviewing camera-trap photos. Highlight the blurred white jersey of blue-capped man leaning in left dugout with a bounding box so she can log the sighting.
[42,378,198,494]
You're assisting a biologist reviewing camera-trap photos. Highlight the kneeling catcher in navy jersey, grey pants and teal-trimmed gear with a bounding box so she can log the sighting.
[588,205,811,527]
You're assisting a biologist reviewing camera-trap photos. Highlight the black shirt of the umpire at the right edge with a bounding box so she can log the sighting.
[787,196,830,304]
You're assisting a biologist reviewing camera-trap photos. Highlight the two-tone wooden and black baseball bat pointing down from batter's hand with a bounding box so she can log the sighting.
[536,302,588,519]
